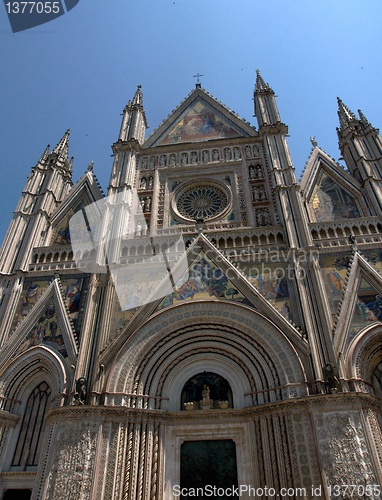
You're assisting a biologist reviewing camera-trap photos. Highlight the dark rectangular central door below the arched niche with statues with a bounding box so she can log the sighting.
[180,439,238,500]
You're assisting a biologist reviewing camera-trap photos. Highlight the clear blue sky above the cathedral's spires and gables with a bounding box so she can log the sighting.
[0,0,382,240]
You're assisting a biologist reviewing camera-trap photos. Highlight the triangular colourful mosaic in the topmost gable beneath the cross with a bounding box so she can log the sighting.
[156,100,239,144]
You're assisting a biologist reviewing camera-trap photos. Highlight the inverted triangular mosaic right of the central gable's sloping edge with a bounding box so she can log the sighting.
[240,262,293,321]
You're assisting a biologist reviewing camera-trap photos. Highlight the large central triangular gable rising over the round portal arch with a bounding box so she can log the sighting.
[100,234,309,365]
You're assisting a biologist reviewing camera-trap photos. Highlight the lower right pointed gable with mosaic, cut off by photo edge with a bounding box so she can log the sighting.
[334,252,382,352]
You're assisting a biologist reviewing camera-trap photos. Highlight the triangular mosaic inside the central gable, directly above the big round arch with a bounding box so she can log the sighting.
[159,252,251,309]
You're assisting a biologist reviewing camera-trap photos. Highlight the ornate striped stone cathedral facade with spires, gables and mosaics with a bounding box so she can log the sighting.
[0,72,382,500]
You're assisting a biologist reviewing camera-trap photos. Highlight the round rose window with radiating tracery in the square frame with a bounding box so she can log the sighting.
[176,183,230,220]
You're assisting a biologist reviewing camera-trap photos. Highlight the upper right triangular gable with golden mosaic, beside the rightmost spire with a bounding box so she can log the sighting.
[301,147,367,222]
